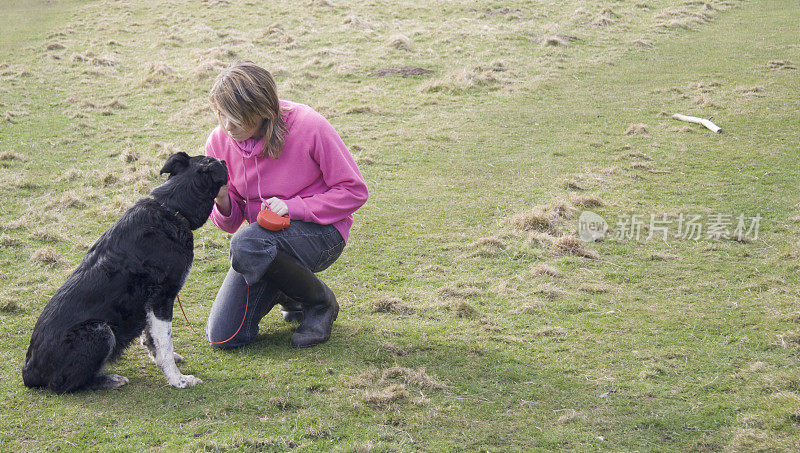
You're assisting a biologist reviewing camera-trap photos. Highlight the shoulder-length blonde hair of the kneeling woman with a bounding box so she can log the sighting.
[209,60,287,159]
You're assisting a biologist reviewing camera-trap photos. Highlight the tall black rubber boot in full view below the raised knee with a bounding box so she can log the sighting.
[265,250,339,348]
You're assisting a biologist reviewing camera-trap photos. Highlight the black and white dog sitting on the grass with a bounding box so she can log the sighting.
[22,152,228,393]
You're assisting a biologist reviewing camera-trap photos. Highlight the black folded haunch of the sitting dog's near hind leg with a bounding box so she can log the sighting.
[47,321,119,393]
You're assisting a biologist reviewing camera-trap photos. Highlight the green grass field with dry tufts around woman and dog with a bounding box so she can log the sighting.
[0,0,800,451]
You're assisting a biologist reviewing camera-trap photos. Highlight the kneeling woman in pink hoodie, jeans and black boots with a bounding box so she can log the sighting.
[206,61,368,348]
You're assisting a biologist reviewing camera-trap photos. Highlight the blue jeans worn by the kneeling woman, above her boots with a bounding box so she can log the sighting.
[206,220,345,349]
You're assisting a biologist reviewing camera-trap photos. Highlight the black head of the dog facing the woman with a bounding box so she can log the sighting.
[150,152,228,229]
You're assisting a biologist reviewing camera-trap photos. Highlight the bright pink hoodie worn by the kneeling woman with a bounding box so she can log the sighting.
[206,101,369,241]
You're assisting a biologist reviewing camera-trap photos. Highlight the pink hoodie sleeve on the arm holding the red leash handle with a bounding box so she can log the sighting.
[286,112,369,225]
